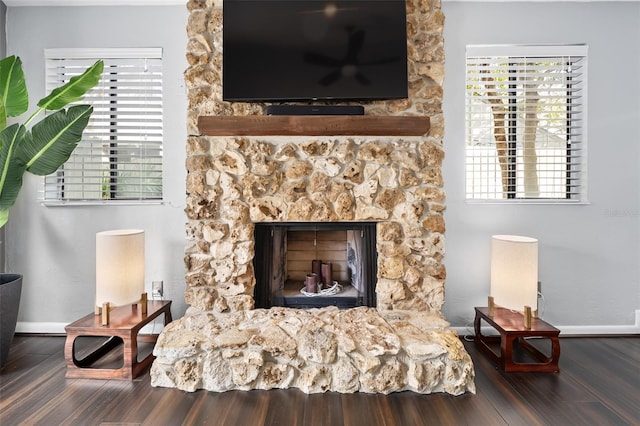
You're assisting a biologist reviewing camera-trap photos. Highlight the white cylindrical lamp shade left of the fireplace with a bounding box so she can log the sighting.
[96,229,144,307]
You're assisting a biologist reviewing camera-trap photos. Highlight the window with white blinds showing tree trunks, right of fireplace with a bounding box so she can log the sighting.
[465,45,587,203]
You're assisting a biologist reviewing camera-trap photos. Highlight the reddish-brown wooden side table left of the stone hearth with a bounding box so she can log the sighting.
[64,300,172,380]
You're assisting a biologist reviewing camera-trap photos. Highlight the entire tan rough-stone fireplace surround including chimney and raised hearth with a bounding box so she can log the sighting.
[151,0,475,395]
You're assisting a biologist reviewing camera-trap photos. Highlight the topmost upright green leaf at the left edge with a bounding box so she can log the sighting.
[0,56,29,123]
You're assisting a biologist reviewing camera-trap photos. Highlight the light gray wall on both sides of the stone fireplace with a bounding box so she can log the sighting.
[7,2,640,333]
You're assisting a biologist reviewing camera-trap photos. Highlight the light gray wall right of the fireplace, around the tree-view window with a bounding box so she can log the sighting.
[443,2,640,332]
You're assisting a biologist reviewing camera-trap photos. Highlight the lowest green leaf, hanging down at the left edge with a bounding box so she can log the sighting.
[0,124,31,211]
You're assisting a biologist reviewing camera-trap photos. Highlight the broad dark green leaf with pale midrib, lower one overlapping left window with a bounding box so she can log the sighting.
[16,105,93,176]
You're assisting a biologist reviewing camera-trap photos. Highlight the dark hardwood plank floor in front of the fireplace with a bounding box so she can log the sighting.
[0,336,640,426]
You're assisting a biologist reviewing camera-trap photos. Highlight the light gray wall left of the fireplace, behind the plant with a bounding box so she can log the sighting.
[7,6,188,331]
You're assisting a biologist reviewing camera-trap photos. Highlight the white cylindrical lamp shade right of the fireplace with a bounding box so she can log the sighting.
[491,235,538,311]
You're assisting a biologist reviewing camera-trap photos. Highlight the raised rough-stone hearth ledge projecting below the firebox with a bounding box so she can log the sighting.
[151,307,475,395]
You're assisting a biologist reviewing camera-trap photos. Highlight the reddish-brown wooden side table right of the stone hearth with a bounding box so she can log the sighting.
[473,308,560,373]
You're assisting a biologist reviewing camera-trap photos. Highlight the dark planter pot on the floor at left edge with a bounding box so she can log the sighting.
[0,274,22,368]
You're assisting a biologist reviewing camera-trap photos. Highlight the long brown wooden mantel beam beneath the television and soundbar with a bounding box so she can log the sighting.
[198,115,430,136]
